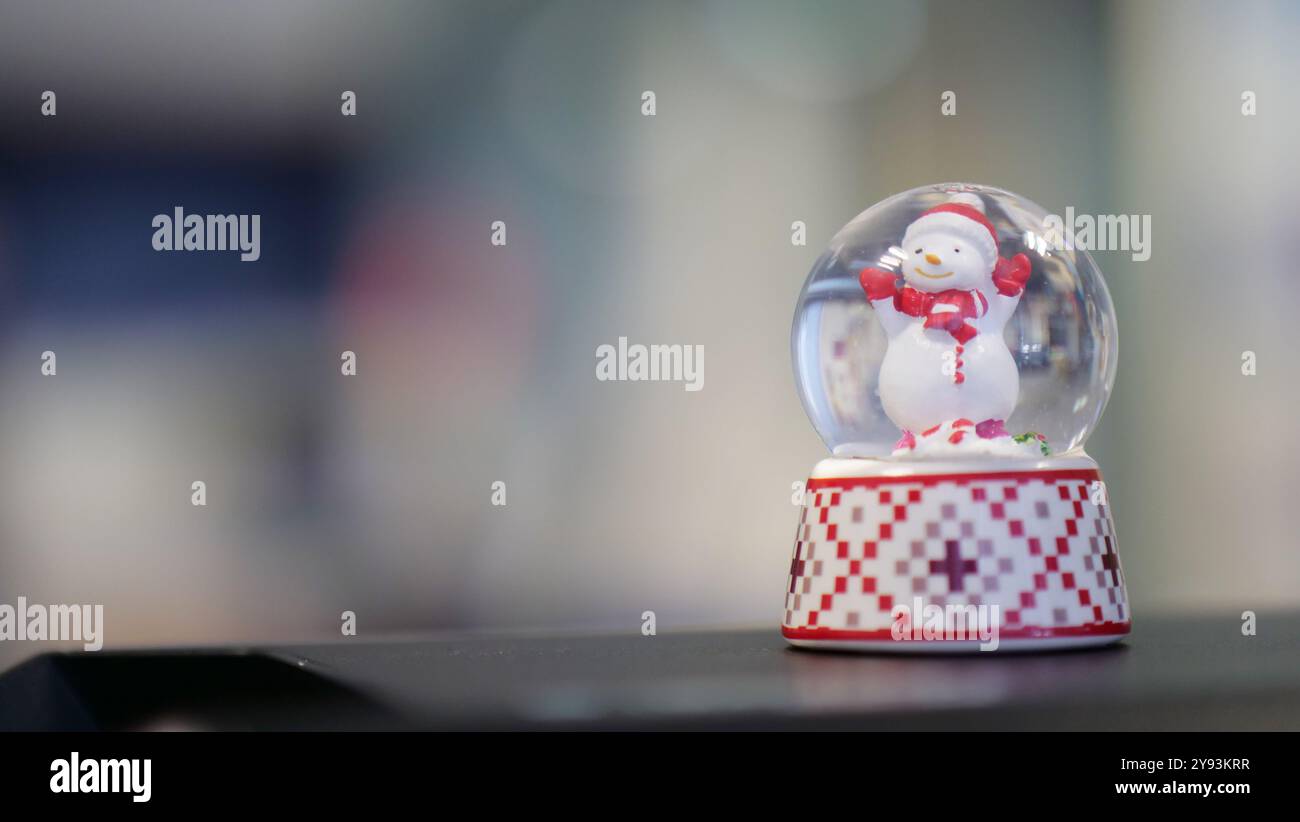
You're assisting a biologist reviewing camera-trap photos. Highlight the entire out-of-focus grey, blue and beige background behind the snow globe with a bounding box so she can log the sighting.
[0,0,1300,667]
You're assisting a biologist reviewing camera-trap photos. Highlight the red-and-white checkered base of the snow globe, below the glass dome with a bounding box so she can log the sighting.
[783,470,1128,640]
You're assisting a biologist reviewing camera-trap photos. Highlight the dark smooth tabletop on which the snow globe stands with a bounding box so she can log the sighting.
[0,614,1300,730]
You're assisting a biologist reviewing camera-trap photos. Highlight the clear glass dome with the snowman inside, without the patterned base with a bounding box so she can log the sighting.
[790,183,1118,459]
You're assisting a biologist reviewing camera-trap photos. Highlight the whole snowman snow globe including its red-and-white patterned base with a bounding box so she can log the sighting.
[783,183,1130,653]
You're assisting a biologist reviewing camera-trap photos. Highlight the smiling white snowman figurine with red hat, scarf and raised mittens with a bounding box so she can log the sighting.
[859,192,1030,455]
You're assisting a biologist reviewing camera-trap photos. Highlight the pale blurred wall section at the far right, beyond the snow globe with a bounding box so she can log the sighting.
[1105,3,1300,617]
